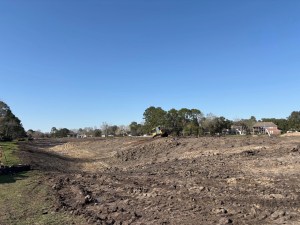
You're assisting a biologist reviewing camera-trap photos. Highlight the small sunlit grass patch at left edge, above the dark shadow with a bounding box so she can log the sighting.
[0,142,21,166]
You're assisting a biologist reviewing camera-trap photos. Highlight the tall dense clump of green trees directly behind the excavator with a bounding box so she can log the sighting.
[129,106,233,136]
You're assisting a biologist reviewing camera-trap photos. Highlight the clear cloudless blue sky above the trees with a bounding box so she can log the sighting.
[0,0,300,131]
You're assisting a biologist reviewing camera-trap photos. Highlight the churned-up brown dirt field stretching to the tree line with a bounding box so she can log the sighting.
[20,136,300,225]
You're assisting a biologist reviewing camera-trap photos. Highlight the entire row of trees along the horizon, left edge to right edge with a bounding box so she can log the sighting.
[0,101,300,141]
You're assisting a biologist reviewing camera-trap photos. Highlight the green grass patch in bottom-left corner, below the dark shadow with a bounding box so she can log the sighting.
[0,171,86,225]
